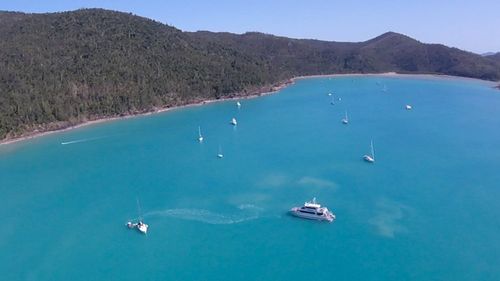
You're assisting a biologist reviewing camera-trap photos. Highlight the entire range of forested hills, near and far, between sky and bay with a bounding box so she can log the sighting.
[0,9,500,139]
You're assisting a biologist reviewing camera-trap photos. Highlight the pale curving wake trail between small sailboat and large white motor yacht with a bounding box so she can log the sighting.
[144,204,260,224]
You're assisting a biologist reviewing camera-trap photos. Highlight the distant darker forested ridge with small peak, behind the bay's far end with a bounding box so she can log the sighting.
[191,31,500,81]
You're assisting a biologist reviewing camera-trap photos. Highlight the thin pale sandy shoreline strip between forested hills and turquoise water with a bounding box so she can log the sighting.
[0,72,500,146]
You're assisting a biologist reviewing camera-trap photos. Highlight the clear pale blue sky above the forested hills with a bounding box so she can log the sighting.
[0,0,500,53]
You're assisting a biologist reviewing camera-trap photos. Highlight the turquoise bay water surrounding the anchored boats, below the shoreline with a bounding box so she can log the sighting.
[0,76,500,281]
